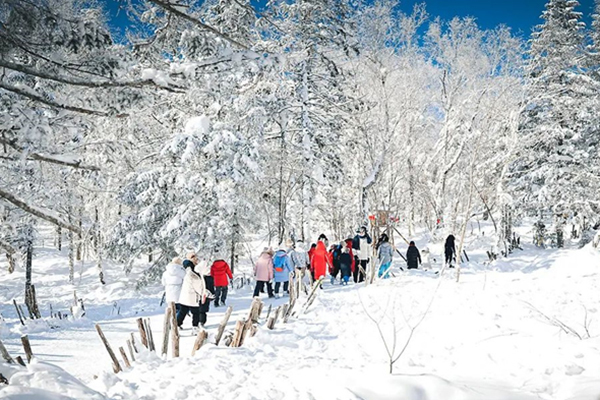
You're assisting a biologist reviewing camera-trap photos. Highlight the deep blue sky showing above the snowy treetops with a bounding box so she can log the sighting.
[103,0,594,37]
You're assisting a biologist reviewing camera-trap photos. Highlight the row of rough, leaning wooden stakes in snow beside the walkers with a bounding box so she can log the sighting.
[96,275,323,373]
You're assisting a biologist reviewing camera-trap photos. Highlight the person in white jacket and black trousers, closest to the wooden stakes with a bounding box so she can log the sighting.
[177,254,207,333]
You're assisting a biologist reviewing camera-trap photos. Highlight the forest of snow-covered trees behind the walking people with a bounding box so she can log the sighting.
[0,0,600,280]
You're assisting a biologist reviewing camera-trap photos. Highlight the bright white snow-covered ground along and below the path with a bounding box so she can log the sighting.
[0,223,600,400]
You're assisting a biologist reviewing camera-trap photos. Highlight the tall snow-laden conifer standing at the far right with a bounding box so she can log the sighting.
[513,0,596,222]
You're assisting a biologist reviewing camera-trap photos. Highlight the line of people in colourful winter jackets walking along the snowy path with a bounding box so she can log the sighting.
[162,230,456,331]
